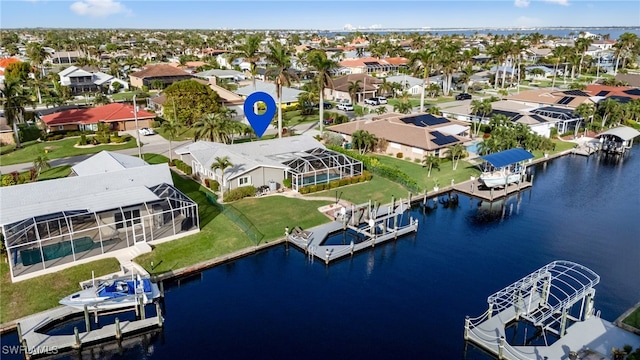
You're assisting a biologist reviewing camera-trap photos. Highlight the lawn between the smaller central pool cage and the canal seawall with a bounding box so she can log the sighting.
[308,175,408,204]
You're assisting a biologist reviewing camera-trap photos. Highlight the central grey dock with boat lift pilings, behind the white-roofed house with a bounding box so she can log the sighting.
[287,200,418,264]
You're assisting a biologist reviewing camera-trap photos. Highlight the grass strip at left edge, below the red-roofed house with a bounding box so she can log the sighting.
[0,137,136,165]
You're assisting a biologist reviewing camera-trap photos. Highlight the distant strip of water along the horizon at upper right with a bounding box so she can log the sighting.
[319,27,640,40]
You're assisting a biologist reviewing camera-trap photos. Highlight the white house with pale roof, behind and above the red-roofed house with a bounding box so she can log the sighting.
[58,66,129,94]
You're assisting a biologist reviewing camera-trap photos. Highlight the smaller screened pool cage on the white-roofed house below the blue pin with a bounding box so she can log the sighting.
[283,148,363,191]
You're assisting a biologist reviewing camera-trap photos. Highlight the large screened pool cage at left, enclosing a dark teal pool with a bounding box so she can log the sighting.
[2,184,200,278]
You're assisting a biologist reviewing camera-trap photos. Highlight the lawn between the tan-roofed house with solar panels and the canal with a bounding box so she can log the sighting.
[375,155,480,191]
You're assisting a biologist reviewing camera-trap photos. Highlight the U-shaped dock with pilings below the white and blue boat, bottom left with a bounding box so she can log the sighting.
[17,303,164,359]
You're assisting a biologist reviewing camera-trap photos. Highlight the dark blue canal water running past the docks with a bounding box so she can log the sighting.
[2,147,640,359]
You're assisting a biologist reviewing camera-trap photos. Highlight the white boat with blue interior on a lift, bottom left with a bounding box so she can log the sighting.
[59,275,160,310]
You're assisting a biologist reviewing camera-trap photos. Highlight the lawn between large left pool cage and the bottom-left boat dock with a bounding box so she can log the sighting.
[0,258,120,323]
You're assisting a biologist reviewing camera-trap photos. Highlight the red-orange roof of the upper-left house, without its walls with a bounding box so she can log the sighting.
[42,103,156,126]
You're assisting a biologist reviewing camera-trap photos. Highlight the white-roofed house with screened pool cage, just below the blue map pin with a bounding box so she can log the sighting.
[175,135,363,191]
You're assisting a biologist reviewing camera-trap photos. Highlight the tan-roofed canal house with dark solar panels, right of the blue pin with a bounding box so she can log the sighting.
[326,113,470,159]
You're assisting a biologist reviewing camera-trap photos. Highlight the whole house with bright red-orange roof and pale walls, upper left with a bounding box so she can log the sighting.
[41,103,156,132]
